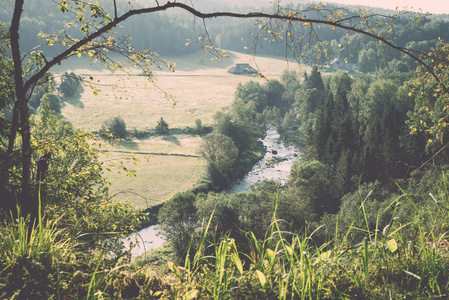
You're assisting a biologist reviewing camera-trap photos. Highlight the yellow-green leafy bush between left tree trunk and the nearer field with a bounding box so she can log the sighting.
[30,110,143,253]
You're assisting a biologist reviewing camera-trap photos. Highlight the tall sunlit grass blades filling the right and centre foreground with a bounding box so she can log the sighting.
[164,184,449,299]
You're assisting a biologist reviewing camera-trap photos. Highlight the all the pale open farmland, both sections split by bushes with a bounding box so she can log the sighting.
[55,52,305,208]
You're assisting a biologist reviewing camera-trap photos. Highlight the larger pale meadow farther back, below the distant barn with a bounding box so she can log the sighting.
[56,51,305,130]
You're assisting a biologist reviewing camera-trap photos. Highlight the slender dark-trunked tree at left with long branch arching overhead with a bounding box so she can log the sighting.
[0,0,448,214]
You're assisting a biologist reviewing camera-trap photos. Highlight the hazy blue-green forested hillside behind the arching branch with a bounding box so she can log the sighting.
[0,0,449,65]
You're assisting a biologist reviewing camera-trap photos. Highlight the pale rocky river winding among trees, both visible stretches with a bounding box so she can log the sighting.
[125,127,299,256]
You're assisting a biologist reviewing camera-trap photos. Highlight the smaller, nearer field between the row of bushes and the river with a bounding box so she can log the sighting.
[106,136,205,209]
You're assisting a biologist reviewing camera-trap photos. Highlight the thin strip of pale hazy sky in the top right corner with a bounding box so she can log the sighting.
[323,0,449,14]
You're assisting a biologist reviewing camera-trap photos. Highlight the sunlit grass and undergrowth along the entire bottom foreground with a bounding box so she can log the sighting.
[0,178,449,299]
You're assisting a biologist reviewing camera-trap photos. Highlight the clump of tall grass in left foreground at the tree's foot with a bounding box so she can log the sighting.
[0,198,127,299]
